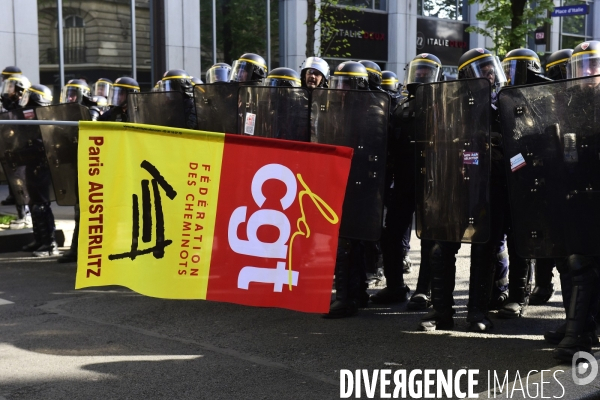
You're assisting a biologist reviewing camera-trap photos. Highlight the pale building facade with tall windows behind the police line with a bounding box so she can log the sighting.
[0,0,600,94]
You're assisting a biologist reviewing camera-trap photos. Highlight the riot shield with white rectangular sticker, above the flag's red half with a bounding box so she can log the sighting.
[237,86,310,142]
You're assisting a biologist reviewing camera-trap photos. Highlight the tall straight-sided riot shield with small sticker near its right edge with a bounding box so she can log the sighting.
[414,78,491,243]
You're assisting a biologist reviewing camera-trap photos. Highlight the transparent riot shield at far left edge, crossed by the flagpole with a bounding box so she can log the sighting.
[0,109,55,205]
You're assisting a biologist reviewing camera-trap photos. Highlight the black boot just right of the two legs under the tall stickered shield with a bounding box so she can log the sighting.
[498,257,531,319]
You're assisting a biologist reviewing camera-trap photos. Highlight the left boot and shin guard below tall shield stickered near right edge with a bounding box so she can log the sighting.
[417,243,456,332]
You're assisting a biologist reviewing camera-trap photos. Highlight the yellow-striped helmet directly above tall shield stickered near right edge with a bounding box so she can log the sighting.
[458,47,506,89]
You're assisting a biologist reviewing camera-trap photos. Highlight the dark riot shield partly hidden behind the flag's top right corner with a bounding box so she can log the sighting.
[311,88,390,241]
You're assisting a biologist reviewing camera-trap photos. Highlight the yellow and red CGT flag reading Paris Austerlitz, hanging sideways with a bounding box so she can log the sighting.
[76,122,352,312]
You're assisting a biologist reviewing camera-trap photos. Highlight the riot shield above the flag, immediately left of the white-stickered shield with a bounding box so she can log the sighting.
[194,82,239,133]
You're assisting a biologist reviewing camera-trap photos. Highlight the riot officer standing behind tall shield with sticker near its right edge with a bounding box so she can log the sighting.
[419,48,510,332]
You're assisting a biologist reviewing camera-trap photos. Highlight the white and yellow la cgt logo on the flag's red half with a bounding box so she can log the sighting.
[227,164,339,292]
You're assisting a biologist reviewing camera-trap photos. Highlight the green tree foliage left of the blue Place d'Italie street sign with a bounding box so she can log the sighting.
[467,0,554,55]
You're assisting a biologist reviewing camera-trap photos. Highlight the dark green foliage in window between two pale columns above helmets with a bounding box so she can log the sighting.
[200,0,279,71]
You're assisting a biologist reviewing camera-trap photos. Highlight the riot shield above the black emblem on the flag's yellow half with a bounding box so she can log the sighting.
[127,92,191,128]
